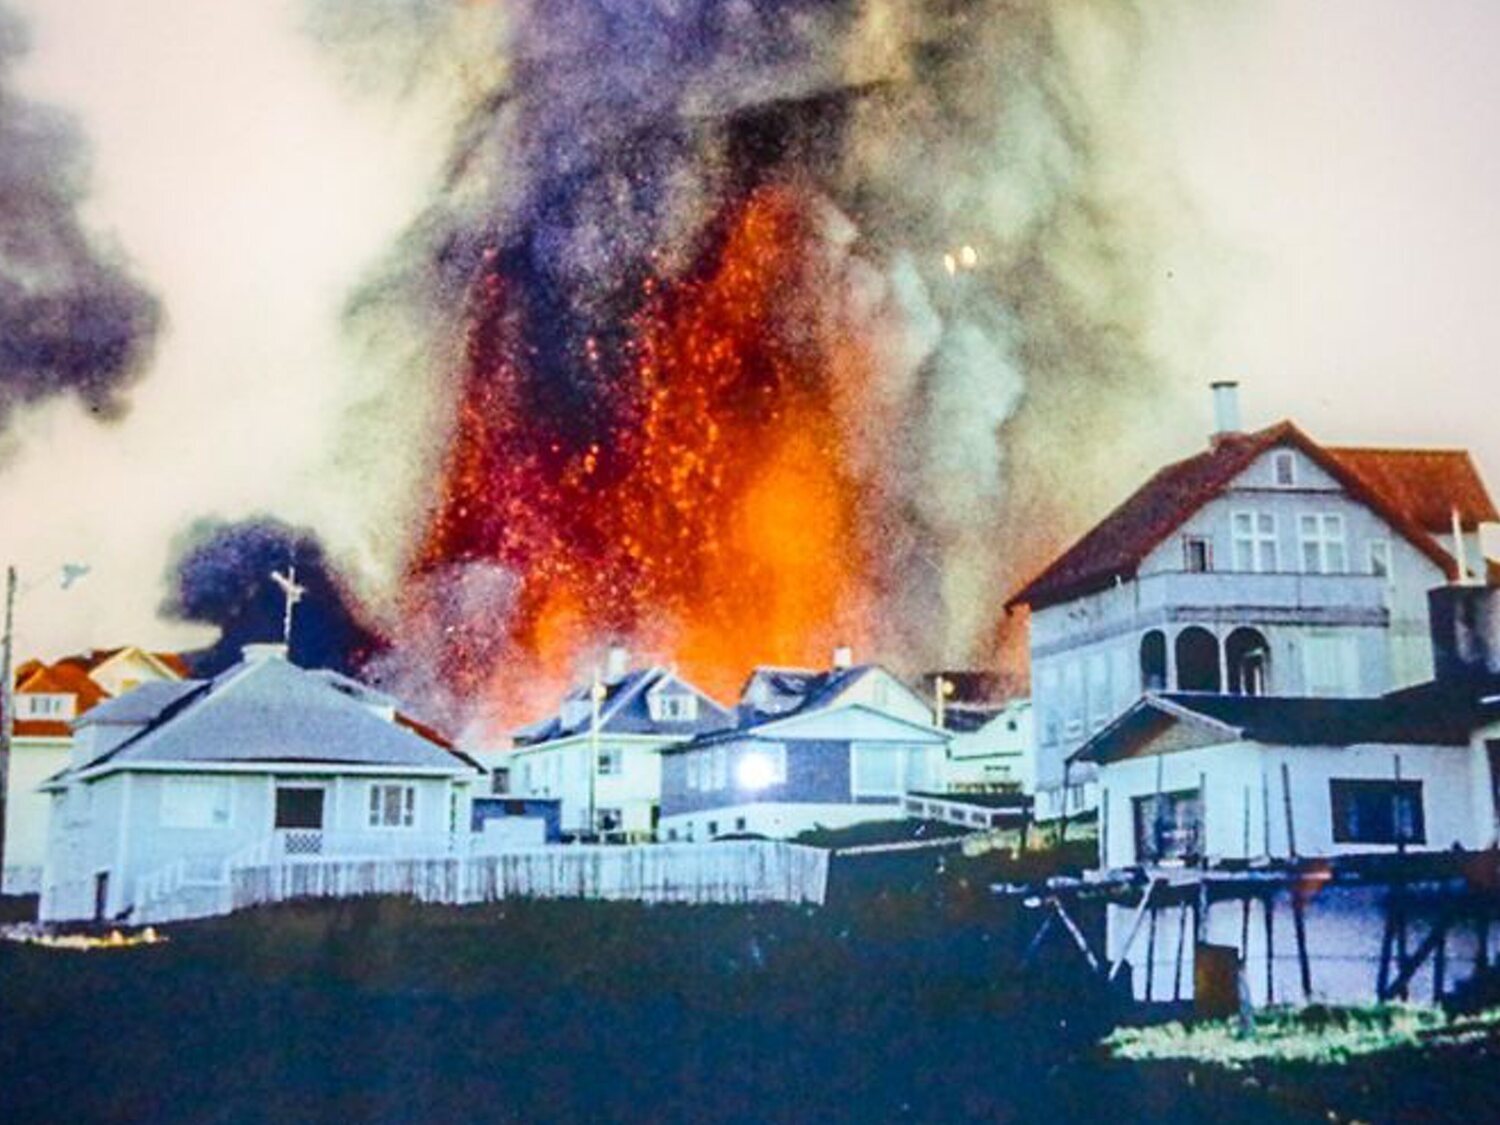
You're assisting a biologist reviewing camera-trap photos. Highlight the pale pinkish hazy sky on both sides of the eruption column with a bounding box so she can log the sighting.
[0,0,1500,654]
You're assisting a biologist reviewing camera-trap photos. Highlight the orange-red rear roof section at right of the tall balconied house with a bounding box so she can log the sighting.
[1329,449,1500,536]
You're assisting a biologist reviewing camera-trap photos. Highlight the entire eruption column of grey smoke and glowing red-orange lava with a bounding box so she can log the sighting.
[309,0,1200,717]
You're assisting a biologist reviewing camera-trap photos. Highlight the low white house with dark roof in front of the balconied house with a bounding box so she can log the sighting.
[1080,689,1496,869]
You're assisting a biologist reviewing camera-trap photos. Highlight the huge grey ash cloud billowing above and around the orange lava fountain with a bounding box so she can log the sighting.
[309,0,1185,693]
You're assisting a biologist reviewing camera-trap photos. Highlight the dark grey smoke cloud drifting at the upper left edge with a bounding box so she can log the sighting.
[0,6,162,423]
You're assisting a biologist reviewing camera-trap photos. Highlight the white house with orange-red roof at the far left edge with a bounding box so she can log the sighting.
[5,645,188,894]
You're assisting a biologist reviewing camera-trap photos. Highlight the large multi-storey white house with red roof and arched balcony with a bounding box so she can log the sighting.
[1008,384,1500,818]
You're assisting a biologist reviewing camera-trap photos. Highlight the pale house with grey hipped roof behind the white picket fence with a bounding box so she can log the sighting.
[41,645,482,921]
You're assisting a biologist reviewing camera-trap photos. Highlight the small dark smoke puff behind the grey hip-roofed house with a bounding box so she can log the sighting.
[161,519,386,675]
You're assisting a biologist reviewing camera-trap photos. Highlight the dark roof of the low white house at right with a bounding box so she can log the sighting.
[1073,692,1476,762]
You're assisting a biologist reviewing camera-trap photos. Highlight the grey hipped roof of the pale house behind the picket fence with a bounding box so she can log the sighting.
[60,657,479,774]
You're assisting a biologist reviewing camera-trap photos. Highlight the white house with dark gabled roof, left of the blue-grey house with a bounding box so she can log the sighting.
[503,647,734,840]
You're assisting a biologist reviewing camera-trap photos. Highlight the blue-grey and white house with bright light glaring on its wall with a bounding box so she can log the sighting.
[659,665,950,840]
